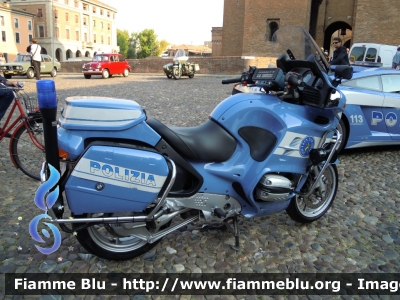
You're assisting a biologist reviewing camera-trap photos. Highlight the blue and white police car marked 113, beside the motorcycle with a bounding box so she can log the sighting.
[338,68,400,150]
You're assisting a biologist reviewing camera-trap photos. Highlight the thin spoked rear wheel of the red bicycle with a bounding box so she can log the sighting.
[11,120,46,180]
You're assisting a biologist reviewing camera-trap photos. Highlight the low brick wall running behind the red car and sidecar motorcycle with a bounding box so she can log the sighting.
[61,56,276,75]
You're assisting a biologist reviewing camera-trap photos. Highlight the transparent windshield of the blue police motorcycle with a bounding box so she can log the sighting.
[272,26,329,73]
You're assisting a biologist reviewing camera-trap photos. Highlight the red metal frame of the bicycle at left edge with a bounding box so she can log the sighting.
[0,91,44,169]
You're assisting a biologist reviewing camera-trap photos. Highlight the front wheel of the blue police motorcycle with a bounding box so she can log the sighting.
[286,165,338,223]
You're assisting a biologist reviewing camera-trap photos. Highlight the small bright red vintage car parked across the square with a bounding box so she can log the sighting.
[82,53,131,79]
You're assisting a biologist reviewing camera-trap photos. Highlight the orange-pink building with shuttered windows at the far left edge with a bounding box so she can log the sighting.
[0,2,35,62]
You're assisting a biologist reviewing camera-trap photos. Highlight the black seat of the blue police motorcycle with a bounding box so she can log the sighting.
[146,118,236,162]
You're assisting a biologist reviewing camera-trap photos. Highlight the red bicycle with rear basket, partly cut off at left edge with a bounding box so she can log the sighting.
[0,83,46,180]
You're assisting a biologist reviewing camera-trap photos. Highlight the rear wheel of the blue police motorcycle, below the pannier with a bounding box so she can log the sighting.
[72,214,171,260]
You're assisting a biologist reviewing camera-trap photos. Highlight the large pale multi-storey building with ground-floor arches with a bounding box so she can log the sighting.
[11,0,119,61]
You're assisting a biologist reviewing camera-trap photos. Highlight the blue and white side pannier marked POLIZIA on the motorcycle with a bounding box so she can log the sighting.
[65,145,169,214]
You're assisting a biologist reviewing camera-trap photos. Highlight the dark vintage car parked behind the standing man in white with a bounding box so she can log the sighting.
[0,54,61,79]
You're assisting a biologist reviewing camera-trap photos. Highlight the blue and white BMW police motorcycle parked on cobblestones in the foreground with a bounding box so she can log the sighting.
[42,27,352,260]
